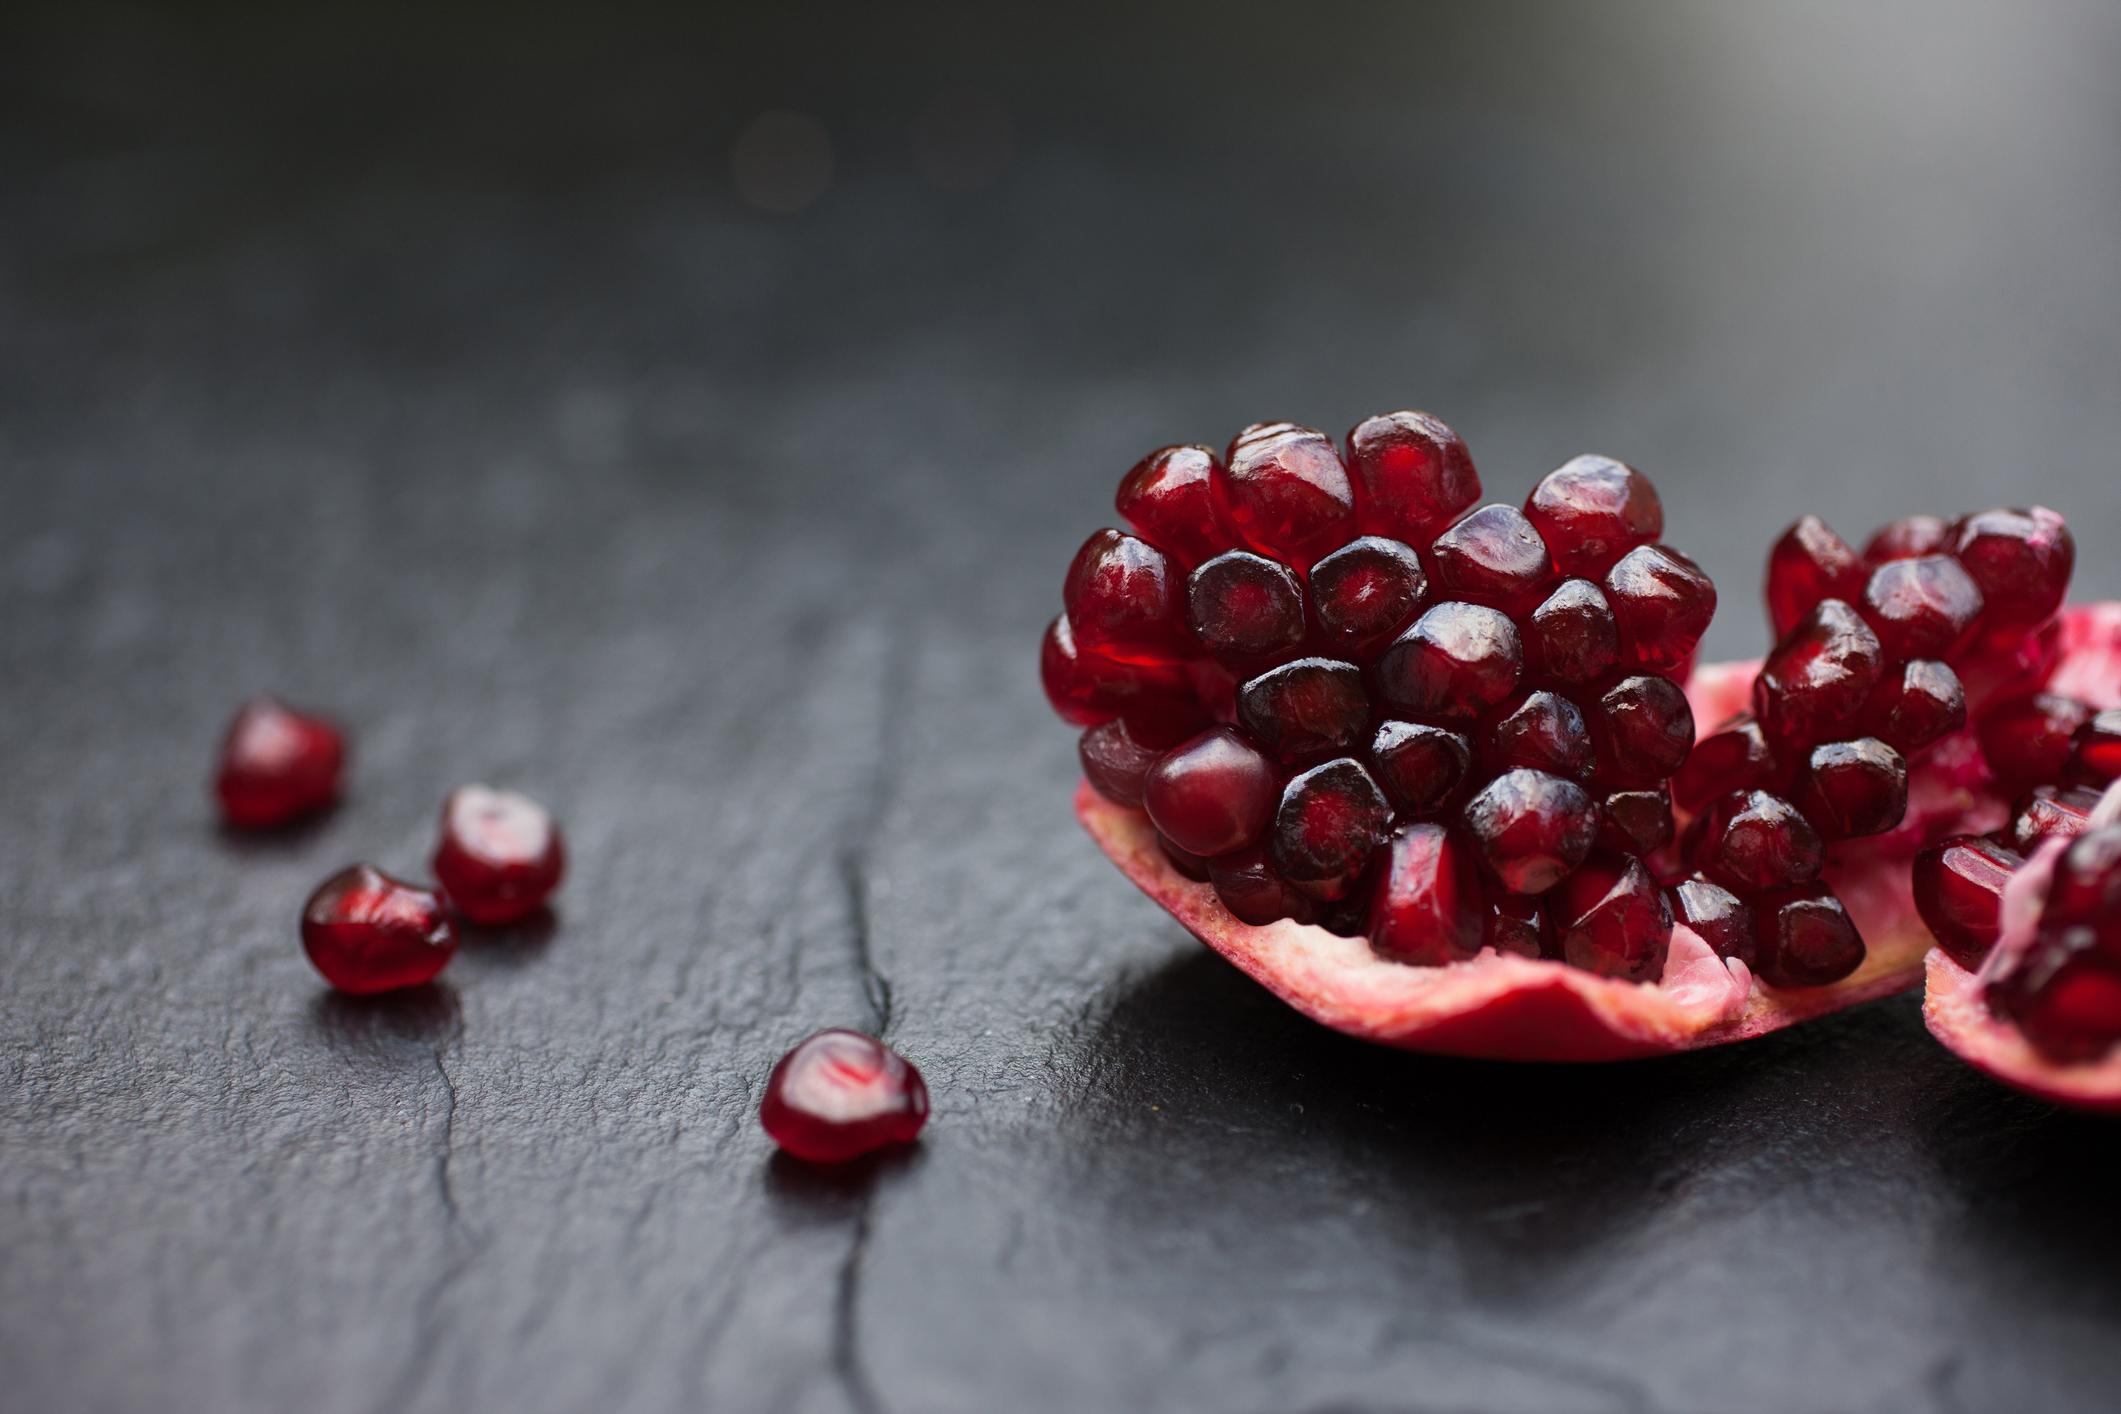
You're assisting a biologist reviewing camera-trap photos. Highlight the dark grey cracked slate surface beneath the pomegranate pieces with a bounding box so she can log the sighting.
[0,4,2121,1414]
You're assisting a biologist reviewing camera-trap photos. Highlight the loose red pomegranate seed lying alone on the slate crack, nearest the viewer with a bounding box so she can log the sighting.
[759,1030,927,1164]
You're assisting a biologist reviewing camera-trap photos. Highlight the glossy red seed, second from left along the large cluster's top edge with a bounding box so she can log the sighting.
[1215,422,1355,572]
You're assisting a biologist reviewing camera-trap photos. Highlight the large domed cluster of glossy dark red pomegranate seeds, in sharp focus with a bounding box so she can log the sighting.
[1041,411,1722,982]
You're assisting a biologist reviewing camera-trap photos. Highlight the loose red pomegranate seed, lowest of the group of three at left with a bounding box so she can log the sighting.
[301,865,456,994]
